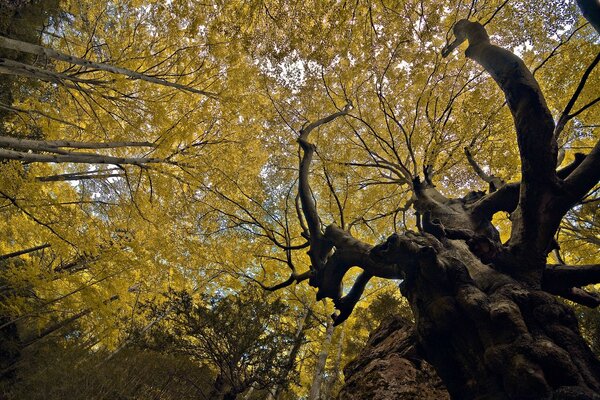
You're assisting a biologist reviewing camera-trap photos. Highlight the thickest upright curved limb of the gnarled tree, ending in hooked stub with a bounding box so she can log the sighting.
[443,20,576,276]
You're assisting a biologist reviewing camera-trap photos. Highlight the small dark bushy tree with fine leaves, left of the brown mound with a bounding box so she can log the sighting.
[141,288,301,400]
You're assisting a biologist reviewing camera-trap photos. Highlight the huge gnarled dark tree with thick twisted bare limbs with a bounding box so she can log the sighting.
[266,10,600,399]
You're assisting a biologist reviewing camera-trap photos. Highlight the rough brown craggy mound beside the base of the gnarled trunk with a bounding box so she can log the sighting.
[338,317,450,400]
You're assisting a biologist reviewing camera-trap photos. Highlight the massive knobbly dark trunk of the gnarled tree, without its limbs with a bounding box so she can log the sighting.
[376,236,600,400]
